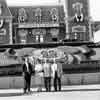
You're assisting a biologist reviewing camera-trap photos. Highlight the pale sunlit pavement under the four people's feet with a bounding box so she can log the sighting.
[0,85,100,100]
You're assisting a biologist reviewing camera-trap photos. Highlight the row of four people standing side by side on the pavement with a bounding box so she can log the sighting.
[23,58,62,93]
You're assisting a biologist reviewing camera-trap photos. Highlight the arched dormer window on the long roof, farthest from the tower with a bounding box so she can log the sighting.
[18,8,27,22]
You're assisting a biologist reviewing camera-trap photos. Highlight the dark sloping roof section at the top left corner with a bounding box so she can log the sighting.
[0,0,12,17]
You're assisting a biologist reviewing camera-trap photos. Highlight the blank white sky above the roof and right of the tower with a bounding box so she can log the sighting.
[6,0,100,42]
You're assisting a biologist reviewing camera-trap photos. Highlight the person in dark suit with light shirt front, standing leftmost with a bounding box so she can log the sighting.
[23,57,32,93]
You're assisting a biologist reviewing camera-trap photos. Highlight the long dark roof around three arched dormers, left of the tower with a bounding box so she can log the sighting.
[9,6,65,23]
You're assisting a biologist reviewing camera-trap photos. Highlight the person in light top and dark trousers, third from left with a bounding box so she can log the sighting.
[43,60,51,92]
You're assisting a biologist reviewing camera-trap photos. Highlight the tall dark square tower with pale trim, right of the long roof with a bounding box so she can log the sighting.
[65,0,93,42]
